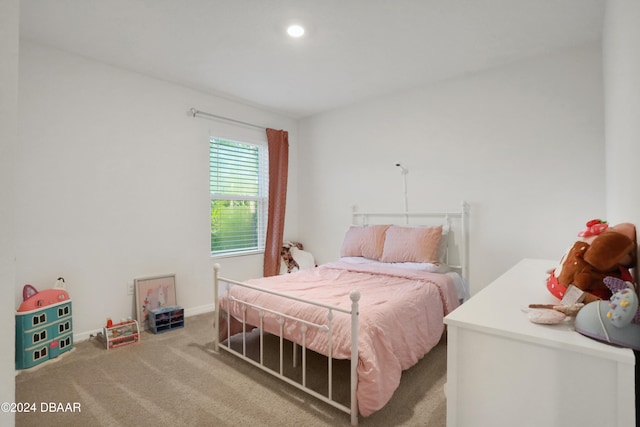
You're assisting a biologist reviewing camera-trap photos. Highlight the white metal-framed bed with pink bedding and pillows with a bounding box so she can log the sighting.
[214,202,469,425]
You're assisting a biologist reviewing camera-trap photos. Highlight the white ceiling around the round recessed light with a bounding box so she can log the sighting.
[20,0,605,118]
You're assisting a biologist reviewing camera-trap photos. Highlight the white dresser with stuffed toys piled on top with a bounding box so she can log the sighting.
[445,259,635,427]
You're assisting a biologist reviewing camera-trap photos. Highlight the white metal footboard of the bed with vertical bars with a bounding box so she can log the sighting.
[213,264,360,426]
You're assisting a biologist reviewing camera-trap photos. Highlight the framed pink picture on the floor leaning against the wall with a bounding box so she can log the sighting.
[134,274,178,330]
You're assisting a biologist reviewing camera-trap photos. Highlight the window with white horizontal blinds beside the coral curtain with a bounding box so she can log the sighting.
[209,137,269,255]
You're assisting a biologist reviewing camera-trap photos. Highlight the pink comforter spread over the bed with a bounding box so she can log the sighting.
[222,262,458,416]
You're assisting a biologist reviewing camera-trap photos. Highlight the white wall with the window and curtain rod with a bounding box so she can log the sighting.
[15,42,298,338]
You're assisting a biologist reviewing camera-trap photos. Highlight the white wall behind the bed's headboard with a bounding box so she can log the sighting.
[299,45,605,293]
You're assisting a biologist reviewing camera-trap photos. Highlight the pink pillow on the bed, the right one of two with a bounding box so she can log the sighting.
[380,225,442,264]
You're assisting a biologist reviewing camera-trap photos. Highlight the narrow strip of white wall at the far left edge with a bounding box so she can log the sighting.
[0,0,20,427]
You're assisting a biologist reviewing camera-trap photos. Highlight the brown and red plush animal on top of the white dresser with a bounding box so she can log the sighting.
[547,220,636,304]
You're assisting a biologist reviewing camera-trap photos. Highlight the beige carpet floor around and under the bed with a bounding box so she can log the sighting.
[16,313,446,427]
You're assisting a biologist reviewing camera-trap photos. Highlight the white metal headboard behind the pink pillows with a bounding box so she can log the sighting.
[352,201,470,283]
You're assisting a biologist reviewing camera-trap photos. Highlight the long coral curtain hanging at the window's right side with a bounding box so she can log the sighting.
[263,129,289,277]
